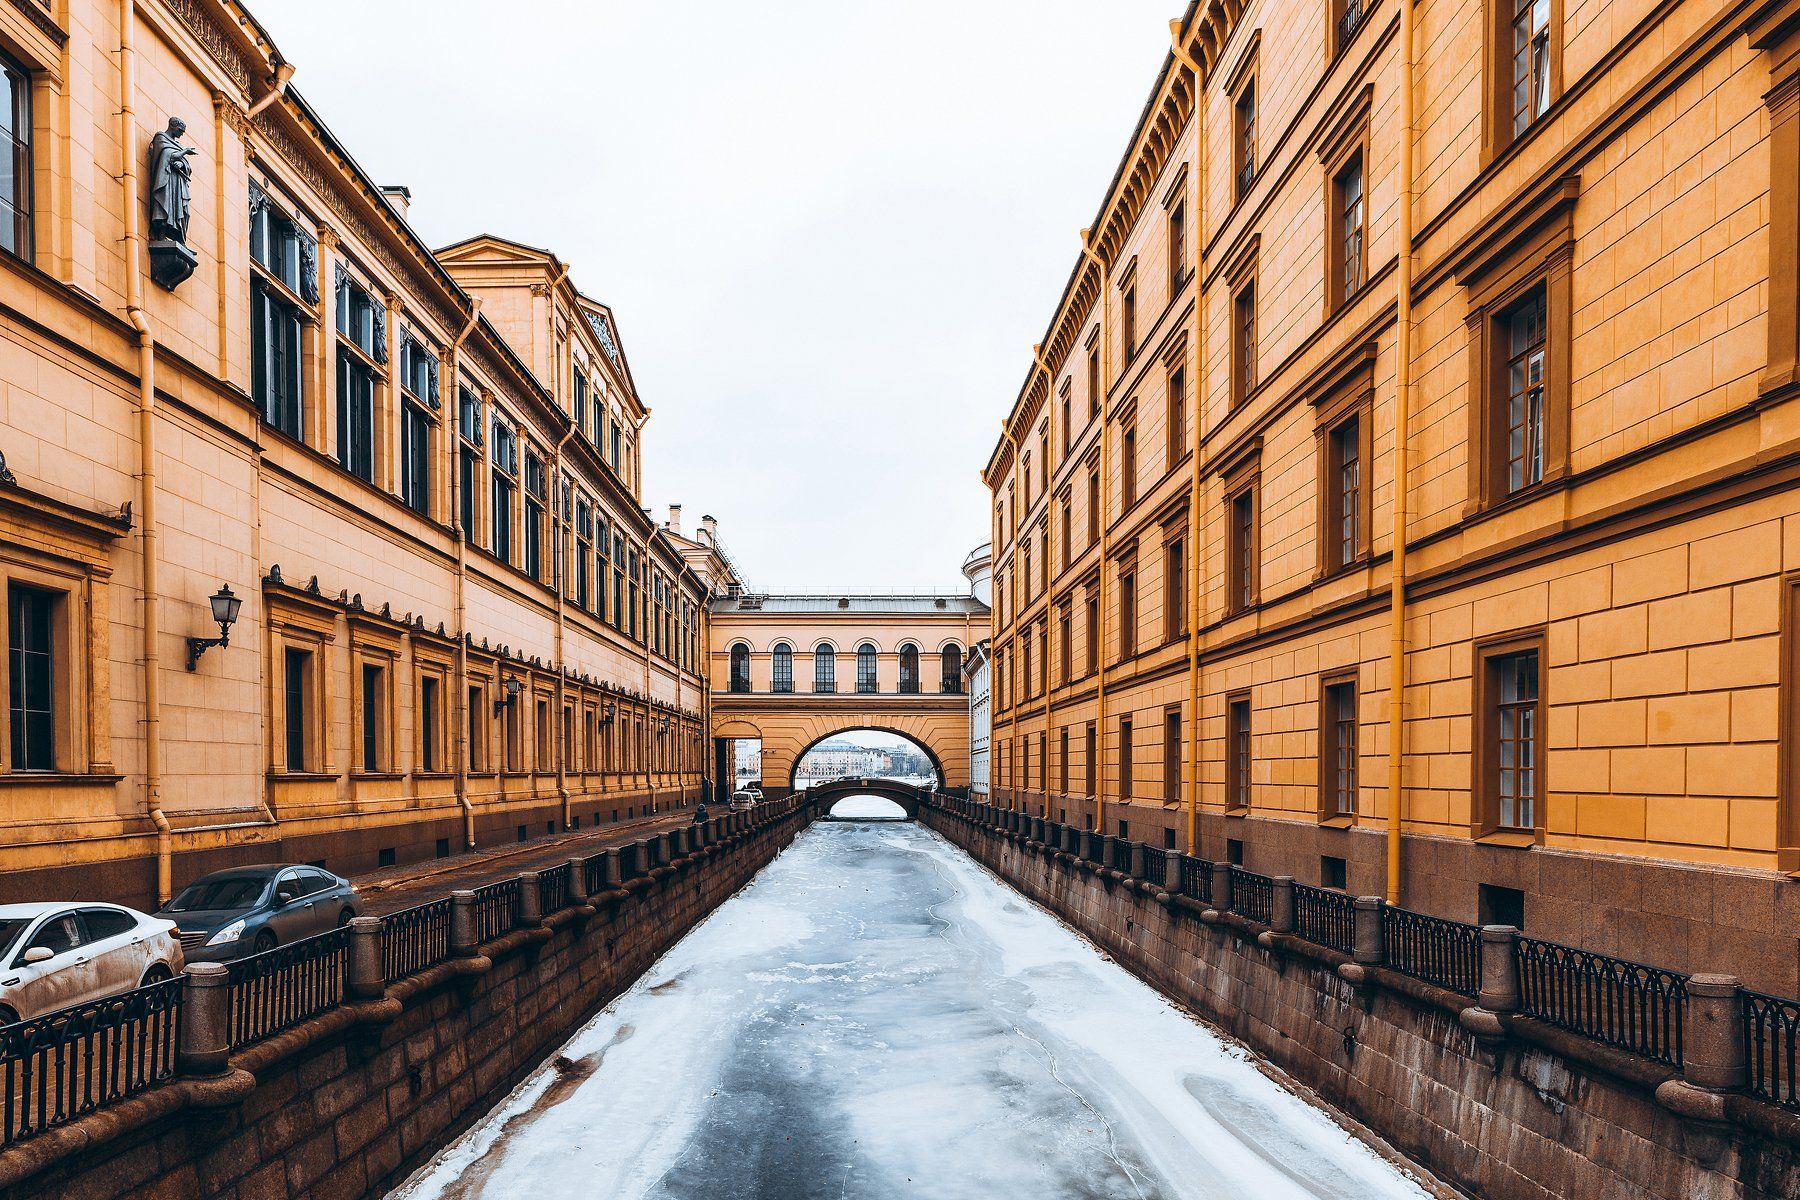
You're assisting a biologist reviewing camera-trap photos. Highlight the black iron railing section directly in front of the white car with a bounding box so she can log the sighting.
[0,977,187,1146]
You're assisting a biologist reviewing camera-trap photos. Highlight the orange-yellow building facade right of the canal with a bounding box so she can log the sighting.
[985,0,1800,993]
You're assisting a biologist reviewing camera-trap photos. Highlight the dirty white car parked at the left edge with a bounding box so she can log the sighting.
[0,901,182,1025]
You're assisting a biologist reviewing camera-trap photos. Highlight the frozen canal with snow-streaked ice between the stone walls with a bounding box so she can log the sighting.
[392,798,1427,1200]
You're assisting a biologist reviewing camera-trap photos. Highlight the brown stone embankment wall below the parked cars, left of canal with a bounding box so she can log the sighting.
[0,810,810,1200]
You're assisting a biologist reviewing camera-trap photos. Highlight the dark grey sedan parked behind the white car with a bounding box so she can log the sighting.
[157,864,362,963]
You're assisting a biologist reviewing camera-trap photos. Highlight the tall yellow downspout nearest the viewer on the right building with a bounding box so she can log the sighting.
[1388,0,1415,905]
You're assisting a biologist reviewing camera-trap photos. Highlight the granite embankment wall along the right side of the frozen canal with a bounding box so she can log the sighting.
[923,801,1800,1200]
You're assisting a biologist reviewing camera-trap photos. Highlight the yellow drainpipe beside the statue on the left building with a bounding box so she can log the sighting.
[119,0,175,907]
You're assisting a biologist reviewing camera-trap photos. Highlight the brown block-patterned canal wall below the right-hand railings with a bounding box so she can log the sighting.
[927,811,1800,1200]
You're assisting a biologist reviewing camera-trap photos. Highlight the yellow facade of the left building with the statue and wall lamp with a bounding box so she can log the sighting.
[0,0,729,903]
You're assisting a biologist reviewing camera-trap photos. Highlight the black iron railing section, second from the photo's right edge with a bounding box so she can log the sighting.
[1516,937,1687,1067]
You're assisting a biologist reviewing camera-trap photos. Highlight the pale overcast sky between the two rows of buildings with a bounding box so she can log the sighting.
[252,0,1184,592]
